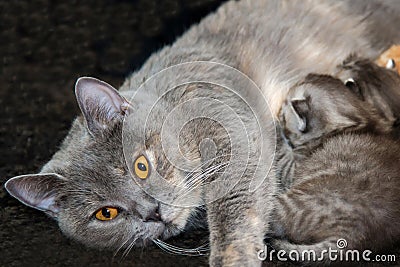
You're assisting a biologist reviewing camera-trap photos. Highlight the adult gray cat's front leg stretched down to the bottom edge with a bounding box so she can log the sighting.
[199,133,274,267]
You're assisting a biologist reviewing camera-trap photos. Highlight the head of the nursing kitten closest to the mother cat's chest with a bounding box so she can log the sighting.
[279,74,391,151]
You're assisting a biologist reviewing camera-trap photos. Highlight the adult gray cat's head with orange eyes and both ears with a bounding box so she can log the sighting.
[5,78,200,249]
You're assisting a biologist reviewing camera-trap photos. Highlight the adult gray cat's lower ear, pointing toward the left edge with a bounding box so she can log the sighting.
[4,173,65,218]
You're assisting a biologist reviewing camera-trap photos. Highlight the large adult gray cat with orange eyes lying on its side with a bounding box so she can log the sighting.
[6,0,400,266]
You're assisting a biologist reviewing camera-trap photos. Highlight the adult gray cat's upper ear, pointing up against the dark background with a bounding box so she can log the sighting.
[75,77,130,134]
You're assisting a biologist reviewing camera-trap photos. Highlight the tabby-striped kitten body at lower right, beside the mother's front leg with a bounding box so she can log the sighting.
[274,134,400,261]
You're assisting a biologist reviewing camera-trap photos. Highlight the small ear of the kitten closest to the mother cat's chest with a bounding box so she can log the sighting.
[286,98,309,133]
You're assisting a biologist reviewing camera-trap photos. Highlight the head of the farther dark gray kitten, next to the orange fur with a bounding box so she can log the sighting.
[337,55,400,129]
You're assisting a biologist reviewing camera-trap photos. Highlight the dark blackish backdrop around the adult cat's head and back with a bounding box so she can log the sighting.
[0,0,227,266]
